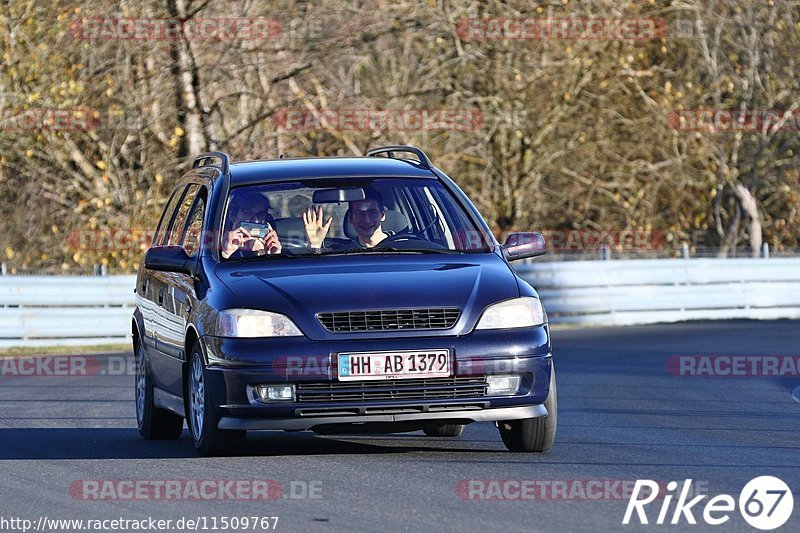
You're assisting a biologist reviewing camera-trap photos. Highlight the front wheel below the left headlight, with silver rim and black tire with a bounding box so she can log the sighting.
[186,342,247,457]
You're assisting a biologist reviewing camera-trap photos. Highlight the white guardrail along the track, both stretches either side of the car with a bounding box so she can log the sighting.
[0,258,800,347]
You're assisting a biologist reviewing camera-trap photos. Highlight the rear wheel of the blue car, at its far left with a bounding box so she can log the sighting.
[134,340,183,440]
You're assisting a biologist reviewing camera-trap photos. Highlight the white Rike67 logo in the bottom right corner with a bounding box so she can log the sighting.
[622,476,794,531]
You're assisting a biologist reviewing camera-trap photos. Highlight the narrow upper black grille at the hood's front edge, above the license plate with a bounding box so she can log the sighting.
[317,307,461,333]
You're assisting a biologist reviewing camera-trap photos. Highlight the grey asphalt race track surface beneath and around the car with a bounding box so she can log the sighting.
[0,321,800,532]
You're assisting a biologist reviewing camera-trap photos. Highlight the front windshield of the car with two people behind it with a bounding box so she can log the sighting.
[222,178,491,260]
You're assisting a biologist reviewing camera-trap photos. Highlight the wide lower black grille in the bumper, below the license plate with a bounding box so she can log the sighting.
[296,376,487,403]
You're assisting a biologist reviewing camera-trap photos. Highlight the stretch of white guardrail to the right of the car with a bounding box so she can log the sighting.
[517,258,800,326]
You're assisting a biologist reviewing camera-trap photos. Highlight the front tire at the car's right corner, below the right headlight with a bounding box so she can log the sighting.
[497,366,558,452]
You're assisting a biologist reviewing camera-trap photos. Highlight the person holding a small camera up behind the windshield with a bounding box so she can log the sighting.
[221,192,282,259]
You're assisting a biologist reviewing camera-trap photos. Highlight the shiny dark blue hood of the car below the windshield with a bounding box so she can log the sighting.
[215,253,519,338]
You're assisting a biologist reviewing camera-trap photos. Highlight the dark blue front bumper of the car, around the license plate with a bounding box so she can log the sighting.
[203,326,552,430]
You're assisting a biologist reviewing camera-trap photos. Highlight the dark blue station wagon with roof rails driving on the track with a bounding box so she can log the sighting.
[132,146,556,455]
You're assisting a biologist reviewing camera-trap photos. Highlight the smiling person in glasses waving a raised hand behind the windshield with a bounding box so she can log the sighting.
[303,187,393,250]
